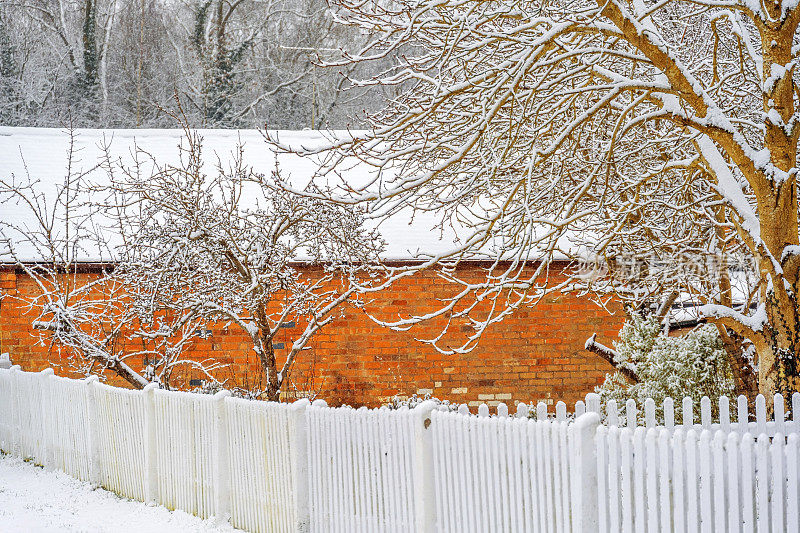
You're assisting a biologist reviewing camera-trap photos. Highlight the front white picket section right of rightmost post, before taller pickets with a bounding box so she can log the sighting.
[597,426,800,533]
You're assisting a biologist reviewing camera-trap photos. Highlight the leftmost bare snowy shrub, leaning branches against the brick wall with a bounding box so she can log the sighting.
[0,131,222,388]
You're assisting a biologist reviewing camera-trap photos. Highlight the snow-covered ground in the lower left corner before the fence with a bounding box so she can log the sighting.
[0,455,239,533]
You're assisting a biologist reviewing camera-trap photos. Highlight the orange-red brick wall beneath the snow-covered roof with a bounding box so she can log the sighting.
[0,266,622,406]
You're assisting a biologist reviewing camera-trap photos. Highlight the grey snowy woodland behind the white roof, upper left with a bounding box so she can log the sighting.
[0,0,389,129]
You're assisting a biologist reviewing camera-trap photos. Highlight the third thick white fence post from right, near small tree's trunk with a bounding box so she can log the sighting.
[289,398,311,533]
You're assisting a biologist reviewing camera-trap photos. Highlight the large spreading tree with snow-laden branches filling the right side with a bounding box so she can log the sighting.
[282,0,800,400]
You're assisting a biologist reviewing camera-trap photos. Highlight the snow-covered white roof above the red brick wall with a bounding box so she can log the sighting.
[0,127,472,261]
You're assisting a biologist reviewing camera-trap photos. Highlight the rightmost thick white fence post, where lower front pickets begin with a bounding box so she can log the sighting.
[571,411,600,533]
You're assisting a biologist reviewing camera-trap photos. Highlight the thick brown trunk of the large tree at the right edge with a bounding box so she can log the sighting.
[753,18,800,399]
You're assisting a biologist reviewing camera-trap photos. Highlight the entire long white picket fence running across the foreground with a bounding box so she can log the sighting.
[0,368,800,533]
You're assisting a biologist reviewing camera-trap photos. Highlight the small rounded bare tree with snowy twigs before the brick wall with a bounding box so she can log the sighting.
[104,125,383,400]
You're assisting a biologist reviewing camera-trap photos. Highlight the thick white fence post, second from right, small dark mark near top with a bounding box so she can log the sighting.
[413,400,437,533]
